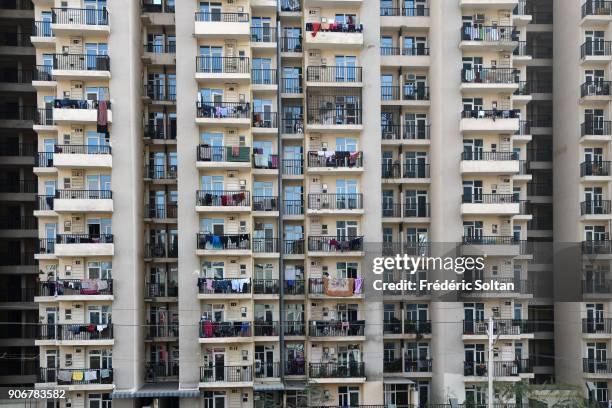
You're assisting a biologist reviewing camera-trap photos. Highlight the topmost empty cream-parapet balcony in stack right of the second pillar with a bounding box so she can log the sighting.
[195,11,251,39]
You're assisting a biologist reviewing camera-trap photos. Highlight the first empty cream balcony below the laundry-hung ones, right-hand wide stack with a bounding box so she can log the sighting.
[461,150,520,174]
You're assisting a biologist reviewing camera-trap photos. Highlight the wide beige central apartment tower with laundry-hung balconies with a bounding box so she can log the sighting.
[21,0,568,408]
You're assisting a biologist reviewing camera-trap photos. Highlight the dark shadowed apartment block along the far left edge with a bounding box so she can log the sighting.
[0,0,38,388]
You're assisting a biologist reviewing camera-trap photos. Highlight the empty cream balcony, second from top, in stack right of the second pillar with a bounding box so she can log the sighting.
[195,56,251,83]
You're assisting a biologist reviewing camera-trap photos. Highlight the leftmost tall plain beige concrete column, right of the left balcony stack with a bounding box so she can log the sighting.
[108,0,144,391]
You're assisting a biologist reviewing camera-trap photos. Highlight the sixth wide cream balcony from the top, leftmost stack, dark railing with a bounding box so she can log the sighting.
[55,234,115,257]
